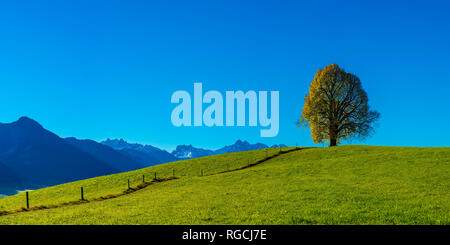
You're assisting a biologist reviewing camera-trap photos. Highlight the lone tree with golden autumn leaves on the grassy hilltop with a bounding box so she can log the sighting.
[297,64,380,146]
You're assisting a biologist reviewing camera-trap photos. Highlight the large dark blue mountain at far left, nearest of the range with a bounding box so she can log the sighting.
[0,117,119,188]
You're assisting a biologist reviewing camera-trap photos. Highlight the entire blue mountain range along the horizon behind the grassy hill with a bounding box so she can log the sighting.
[0,117,284,195]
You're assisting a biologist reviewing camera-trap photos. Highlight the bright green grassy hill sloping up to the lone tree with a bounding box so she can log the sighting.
[0,146,450,225]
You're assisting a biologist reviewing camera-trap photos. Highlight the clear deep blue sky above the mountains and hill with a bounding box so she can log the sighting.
[0,0,450,149]
